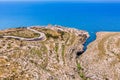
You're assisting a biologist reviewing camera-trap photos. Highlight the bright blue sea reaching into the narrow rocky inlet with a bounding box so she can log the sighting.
[0,2,120,45]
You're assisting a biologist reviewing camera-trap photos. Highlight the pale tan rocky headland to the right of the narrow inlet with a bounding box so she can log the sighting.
[78,32,120,80]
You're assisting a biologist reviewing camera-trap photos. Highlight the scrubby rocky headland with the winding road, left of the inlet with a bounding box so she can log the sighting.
[0,26,89,80]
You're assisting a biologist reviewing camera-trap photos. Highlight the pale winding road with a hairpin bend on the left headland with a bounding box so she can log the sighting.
[3,27,46,41]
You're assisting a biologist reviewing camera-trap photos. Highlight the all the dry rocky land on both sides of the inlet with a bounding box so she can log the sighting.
[0,25,120,80]
